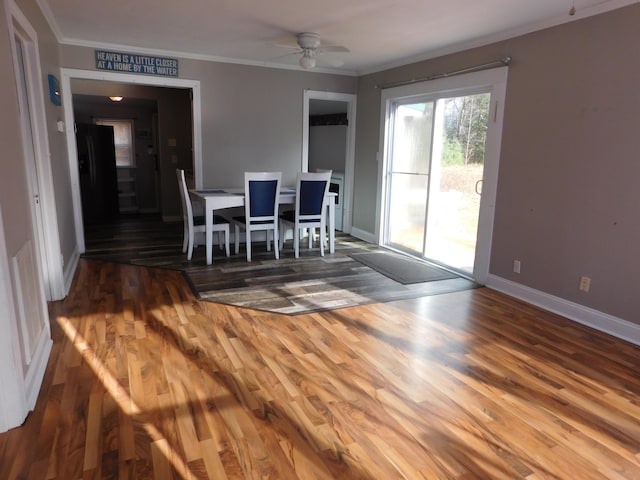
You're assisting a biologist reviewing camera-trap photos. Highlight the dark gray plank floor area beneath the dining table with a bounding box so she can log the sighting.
[83,218,478,315]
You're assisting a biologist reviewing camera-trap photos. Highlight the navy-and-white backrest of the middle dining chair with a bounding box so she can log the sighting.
[244,172,282,223]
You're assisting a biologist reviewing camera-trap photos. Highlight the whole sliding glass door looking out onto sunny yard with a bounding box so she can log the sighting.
[381,69,508,279]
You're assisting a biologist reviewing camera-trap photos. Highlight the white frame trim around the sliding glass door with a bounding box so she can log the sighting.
[376,67,508,284]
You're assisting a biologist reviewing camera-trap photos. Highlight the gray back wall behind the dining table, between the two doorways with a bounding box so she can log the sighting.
[61,46,357,187]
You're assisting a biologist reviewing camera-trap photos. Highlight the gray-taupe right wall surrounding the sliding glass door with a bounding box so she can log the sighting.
[353,4,640,323]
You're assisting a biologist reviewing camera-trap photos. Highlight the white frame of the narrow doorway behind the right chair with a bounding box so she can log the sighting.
[302,90,356,233]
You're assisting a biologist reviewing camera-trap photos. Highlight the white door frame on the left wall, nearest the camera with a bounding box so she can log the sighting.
[5,0,66,300]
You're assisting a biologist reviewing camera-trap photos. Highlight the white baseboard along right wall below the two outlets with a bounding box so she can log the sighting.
[486,275,640,345]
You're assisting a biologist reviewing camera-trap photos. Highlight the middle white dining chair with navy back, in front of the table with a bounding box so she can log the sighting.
[232,172,282,262]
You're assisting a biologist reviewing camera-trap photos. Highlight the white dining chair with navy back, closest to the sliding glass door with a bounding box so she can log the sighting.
[280,170,331,258]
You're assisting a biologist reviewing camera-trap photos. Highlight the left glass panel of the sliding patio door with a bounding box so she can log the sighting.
[386,102,434,253]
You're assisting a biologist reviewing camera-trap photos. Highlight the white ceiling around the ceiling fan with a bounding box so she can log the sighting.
[37,0,638,75]
